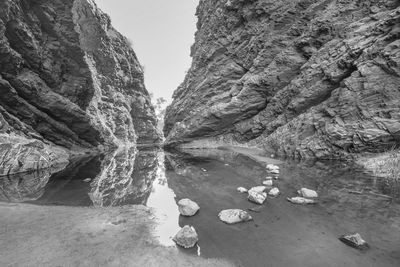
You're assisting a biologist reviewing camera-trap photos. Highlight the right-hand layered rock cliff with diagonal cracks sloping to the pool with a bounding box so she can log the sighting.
[164,0,400,158]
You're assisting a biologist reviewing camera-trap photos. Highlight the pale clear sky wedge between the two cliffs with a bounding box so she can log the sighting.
[95,0,198,100]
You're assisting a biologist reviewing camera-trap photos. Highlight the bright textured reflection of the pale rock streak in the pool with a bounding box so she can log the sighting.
[89,148,158,207]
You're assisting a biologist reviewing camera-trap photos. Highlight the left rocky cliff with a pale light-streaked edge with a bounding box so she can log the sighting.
[0,0,160,175]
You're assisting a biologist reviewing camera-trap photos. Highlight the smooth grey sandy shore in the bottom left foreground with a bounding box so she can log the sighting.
[0,203,231,266]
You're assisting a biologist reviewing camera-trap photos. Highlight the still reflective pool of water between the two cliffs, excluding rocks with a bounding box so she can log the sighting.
[0,149,400,266]
